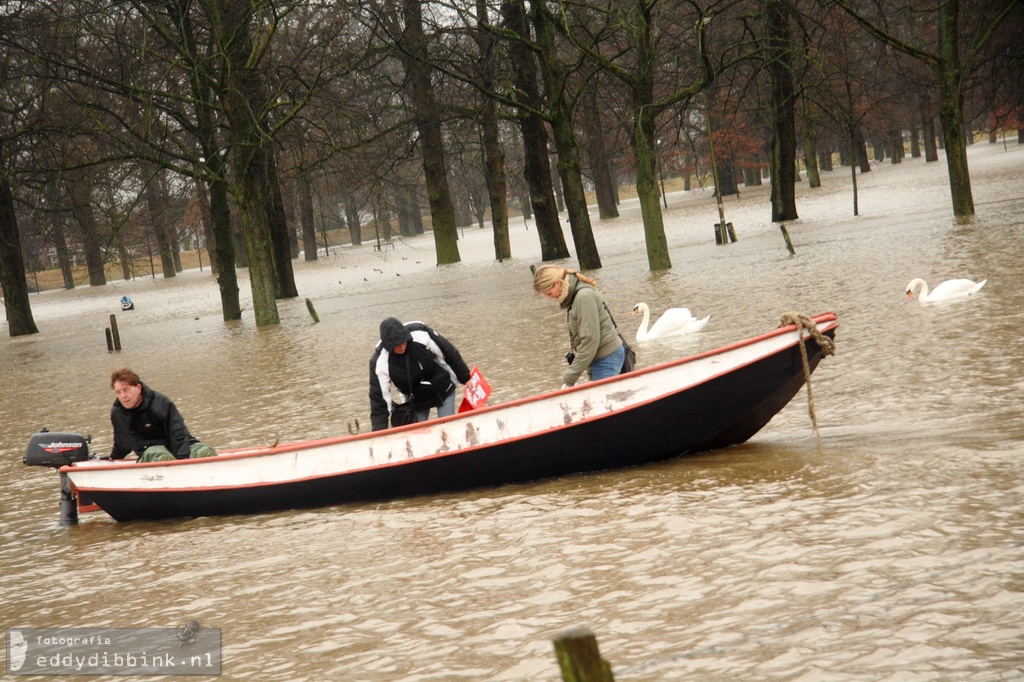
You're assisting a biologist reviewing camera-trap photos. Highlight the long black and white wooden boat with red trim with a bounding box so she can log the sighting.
[26,313,838,523]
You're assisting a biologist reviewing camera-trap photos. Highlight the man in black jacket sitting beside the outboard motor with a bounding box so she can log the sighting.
[111,368,217,462]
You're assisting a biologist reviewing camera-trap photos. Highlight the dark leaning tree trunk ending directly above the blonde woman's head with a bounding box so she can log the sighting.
[502,0,569,261]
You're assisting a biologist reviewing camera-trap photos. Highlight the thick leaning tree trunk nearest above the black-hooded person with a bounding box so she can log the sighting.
[400,0,461,265]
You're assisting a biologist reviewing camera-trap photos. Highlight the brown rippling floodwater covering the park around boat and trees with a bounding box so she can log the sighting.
[6,144,1024,682]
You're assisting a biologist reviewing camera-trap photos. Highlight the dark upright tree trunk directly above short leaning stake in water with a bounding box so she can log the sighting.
[765,0,800,222]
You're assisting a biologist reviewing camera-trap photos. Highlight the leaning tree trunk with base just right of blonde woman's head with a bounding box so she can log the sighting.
[531,3,601,270]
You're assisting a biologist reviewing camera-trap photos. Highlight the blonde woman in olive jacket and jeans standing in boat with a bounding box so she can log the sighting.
[534,265,626,388]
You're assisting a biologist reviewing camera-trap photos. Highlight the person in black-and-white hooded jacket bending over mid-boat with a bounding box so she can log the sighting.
[370,317,470,431]
